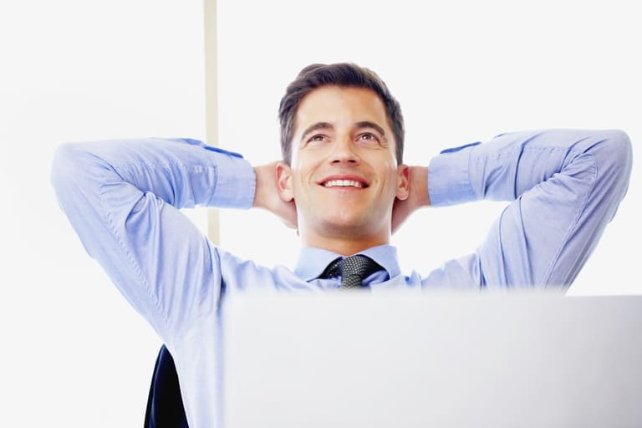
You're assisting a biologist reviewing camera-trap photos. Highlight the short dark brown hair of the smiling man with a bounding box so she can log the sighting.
[279,63,404,165]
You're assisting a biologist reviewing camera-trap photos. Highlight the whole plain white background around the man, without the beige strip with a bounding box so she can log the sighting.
[0,0,642,427]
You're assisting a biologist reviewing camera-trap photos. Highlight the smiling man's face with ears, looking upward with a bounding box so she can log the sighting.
[279,86,408,245]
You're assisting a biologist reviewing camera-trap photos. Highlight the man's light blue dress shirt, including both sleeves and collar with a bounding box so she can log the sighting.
[52,130,632,428]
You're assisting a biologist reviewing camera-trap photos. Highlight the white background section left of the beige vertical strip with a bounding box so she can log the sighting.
[0,0,205,427]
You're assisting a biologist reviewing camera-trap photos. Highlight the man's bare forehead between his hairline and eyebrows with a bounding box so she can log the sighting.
[294,86,388,134]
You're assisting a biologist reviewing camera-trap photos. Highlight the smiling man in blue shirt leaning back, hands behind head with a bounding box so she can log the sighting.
[52,64,631,427]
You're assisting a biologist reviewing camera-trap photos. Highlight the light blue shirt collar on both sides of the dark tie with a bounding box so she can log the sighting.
[294,245,401,281]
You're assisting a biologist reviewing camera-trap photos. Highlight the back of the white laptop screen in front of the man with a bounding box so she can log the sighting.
[223,292,642,428]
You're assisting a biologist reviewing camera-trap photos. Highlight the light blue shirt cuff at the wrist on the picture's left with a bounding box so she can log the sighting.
[209,148,256,209]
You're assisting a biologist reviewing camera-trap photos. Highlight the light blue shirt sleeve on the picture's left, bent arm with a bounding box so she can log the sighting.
[51,139,255,346]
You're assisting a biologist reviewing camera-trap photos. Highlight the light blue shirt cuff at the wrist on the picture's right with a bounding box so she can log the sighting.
[428,143,480,207]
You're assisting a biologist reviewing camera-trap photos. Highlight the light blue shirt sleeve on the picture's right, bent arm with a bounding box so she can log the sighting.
[428,129,632,288]
